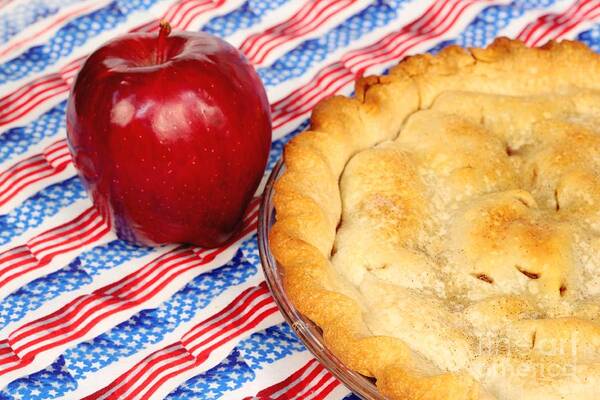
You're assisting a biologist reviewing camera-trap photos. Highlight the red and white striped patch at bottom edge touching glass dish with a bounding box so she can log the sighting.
[244,359,341,400]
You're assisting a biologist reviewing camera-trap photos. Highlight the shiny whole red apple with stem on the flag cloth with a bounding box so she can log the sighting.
[67,23,271,247]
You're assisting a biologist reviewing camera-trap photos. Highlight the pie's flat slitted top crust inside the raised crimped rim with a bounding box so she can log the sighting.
[331,90,600,399]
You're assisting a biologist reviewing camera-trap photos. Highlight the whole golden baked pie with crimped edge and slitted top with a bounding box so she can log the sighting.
[270,38,600,400]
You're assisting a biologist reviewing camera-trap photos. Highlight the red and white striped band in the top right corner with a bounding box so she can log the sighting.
[518,0,600,46]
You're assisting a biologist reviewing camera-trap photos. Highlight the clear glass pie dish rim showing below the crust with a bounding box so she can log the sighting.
[258,160,385,400]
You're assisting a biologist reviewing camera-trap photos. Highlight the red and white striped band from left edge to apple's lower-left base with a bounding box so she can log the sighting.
[0,207,110,297]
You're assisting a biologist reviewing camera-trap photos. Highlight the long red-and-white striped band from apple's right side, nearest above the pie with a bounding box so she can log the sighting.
[271,0,500,136]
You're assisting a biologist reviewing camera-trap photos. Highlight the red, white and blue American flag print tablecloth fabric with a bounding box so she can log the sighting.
[0,0,600,399]
